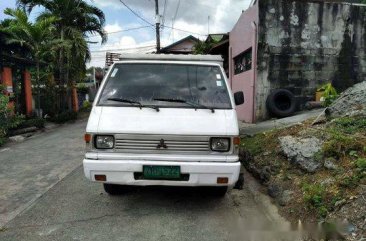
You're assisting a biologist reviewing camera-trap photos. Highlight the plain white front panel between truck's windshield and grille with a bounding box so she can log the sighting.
[87,106,239,136]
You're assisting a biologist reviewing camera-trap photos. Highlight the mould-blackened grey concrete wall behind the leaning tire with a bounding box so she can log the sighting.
[256,0,366,119]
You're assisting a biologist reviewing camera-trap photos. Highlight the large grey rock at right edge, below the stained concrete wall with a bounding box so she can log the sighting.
[325,81,366,118]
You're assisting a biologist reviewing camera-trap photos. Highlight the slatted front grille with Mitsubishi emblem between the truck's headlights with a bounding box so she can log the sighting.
[115,135,210,153]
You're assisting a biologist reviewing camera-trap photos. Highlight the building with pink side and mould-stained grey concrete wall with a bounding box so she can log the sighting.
[228,0,366,123]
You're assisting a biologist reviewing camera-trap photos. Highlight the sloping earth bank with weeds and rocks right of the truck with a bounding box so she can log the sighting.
[241,88,366,235]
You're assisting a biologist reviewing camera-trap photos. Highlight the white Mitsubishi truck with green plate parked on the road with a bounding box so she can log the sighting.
[83,54,244,195]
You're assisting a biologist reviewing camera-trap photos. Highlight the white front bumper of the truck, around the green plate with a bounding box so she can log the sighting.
[83,159,240,186]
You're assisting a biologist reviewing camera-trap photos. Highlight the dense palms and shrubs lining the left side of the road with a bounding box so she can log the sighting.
[0,0,107,146]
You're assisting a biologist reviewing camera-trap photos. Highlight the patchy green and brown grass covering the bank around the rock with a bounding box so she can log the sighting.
[242,117,366,221]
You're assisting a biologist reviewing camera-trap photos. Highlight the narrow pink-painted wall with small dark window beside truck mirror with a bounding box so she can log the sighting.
[229,1,258,123]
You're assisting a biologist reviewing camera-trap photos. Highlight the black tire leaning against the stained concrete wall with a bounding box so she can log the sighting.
[266,89,297,117]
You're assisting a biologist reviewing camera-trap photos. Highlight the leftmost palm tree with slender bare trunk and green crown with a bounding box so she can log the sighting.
[2,8,58,116]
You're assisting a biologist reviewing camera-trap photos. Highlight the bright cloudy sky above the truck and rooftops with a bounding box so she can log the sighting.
[0,0,251,67]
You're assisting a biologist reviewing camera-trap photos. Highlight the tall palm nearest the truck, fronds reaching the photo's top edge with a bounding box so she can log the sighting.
[17,0,107,110]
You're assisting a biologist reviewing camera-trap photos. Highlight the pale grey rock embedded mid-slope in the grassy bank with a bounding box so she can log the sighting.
[279,136,323,172]
